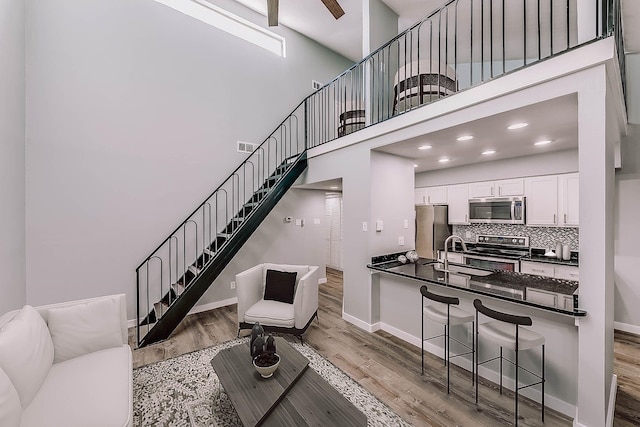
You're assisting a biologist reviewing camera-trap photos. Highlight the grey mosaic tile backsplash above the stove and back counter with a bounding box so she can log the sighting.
[453,224,580,251]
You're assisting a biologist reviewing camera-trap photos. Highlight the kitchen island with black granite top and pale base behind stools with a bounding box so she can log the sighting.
[367,256,587,417]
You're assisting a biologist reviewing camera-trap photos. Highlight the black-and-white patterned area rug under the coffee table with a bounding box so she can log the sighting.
[133,337,409,427]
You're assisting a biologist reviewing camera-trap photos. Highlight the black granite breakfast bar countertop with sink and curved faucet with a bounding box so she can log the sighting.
[367,254,586,317]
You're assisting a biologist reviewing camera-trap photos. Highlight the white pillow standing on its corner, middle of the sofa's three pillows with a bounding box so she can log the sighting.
[0,305,53,408]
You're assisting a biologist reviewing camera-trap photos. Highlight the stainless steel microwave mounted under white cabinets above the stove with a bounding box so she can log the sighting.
[469,196,525,224]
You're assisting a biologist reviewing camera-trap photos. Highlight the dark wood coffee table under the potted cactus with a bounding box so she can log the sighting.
[211,337,367,426]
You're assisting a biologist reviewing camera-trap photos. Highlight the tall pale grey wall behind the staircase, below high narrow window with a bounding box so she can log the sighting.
[26,0,350,317]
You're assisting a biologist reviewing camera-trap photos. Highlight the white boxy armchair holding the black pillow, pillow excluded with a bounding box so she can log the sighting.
[236,263,319,339]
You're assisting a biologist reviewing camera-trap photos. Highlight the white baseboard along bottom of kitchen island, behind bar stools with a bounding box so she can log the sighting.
[380,323,576,418]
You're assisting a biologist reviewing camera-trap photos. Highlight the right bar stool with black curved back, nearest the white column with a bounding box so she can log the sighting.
[473,299,545,426]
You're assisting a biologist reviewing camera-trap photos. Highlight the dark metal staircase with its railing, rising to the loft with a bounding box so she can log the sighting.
[136,103,307,347]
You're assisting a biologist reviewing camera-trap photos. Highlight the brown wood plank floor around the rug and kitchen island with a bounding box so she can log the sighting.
[130,269,640,427]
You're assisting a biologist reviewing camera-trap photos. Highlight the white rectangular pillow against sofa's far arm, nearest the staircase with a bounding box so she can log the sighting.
[49,299,123,363]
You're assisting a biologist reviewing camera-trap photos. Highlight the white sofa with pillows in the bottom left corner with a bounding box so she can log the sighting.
[0,294,133,427]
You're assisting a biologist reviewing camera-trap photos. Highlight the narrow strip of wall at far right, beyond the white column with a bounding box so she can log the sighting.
[615,54,640,334]
